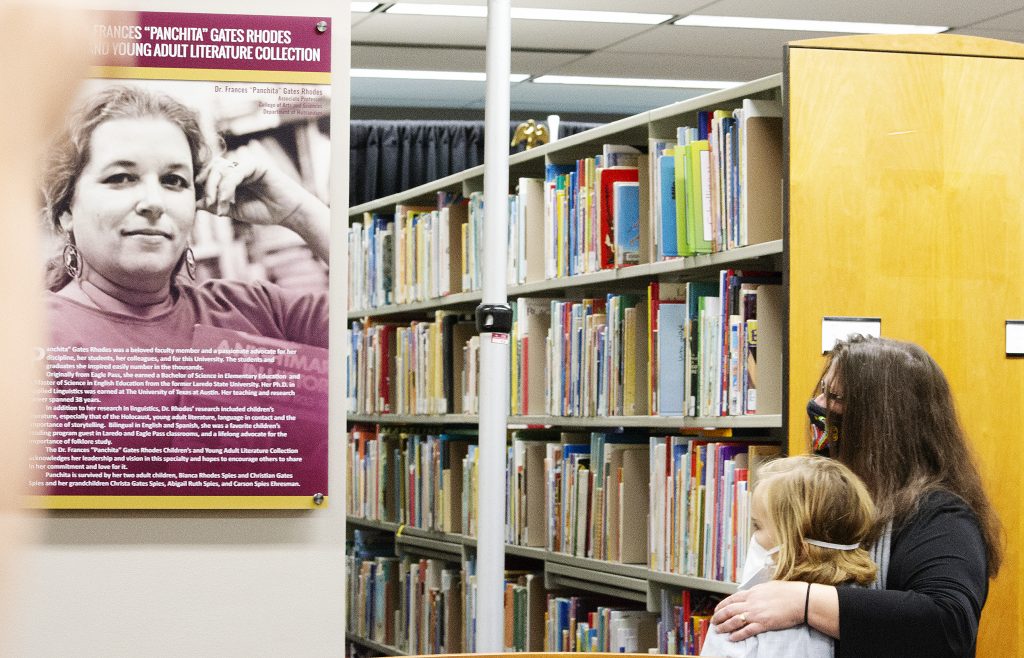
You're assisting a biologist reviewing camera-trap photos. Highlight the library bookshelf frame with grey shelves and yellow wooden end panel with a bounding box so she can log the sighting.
[348,35,1024,655]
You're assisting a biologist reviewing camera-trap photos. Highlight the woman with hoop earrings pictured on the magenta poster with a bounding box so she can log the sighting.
[44,86,330,348]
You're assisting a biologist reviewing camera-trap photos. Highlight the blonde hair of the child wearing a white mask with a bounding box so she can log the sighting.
[756,455,878,585]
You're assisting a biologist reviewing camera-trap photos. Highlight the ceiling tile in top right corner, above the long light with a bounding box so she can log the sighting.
[697,0,1020,28]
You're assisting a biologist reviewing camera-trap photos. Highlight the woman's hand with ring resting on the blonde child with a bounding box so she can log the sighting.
[711,580,807,642]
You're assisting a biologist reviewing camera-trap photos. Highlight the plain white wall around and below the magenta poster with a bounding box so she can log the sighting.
[0,0,350,656]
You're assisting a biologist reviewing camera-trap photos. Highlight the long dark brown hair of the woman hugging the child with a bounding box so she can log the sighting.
[819,336,1002,577]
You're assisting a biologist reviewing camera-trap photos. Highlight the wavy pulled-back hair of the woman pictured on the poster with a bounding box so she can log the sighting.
[42,85,212,291]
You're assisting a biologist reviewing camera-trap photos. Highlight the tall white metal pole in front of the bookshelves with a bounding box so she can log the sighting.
[476,0,512,653]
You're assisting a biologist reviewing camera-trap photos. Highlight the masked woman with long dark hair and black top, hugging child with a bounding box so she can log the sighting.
[712,337,1002,657]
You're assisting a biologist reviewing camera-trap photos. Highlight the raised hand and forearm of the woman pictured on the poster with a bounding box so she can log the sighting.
[196,146,330,262]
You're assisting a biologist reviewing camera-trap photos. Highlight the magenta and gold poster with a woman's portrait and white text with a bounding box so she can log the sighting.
[26,11,331,515]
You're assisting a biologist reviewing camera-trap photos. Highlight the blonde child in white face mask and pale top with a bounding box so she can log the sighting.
[700,456,878,658]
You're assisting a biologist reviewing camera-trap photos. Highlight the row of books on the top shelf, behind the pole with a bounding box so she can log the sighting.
[348,98,782,309]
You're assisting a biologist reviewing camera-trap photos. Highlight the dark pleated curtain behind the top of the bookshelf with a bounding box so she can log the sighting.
[348,121,600,206]
